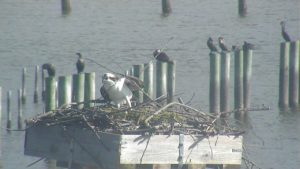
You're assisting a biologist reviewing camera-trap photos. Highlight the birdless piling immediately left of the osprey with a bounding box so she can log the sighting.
[84,72,96,108]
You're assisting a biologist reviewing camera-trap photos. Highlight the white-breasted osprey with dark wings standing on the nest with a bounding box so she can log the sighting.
[100,73,143,108]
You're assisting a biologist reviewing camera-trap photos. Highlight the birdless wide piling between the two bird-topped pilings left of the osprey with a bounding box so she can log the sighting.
[58,76,72,107]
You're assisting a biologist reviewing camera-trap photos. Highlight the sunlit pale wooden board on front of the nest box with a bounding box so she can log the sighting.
[120,135,242,164]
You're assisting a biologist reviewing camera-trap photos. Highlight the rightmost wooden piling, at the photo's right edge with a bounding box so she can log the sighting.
[289,41,299,108]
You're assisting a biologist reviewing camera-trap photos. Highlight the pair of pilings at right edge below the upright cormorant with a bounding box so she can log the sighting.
[279,40,300,109]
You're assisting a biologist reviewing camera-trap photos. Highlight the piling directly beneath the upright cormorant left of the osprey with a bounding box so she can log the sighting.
[72,73,85,109]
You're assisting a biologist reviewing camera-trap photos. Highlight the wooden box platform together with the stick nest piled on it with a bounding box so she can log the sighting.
[25,103,242,169]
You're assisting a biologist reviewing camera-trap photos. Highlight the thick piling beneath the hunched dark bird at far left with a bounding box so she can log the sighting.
[45,77,56,112]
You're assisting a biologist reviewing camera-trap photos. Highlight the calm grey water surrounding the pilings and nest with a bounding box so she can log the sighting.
[0,0,300,169]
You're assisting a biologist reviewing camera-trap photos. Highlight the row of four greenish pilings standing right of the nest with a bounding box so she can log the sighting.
[209,49,252,116]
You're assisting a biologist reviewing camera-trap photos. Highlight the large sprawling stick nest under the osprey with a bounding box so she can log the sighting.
[27,101,244,136]
